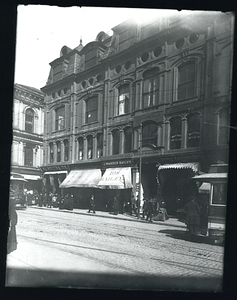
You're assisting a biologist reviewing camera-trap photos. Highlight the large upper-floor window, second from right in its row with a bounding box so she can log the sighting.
[142,68,159,108]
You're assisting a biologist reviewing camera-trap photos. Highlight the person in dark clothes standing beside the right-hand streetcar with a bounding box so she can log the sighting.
[185,196,200,234]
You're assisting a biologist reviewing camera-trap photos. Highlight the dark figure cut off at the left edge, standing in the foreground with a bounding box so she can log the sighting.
[7,188,17,254]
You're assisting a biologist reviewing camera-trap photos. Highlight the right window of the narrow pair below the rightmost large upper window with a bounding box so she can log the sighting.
[187,114,200,148]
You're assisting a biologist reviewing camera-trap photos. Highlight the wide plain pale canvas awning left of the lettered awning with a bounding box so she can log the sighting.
[59,169,101,188]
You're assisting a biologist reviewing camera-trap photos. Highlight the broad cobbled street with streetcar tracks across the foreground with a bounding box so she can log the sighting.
[6,207,224,291]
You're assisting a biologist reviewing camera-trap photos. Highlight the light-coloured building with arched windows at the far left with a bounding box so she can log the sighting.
[11,84,44,192]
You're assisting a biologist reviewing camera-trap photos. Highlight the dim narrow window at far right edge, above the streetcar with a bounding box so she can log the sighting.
[218,108,230,145]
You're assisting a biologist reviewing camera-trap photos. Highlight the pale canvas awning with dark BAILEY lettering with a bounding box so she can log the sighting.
[98,167,132,190]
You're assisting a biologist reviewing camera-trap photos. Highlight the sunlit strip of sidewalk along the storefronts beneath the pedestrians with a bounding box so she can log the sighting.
[28,205,186,229]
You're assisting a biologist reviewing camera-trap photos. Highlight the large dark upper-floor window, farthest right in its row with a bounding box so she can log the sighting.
[178,61,196,100]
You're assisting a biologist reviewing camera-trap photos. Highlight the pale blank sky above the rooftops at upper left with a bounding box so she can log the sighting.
[14,5,192,89]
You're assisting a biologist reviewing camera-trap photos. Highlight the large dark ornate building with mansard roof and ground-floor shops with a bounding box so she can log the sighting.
[42,12,234,214]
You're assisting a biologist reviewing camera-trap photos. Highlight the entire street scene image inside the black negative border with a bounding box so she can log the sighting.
[5,5,235,292]
